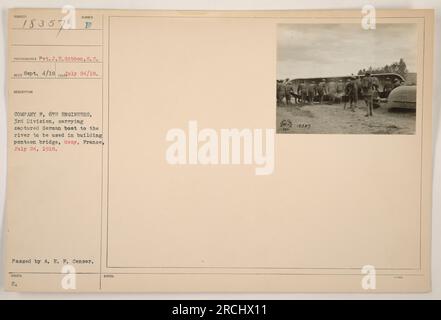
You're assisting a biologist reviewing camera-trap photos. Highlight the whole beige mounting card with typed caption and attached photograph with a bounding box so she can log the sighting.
[5,7,434,292]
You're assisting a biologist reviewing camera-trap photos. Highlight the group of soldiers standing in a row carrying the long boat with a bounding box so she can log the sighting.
[277,72,400,117]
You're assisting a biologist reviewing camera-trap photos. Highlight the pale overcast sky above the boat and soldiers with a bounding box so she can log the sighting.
[277,24,417,79]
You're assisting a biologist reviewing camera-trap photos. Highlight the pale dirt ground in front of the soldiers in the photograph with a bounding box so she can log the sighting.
[277,101,416,134]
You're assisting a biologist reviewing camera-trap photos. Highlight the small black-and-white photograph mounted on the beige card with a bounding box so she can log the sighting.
[276,23,418,135]
